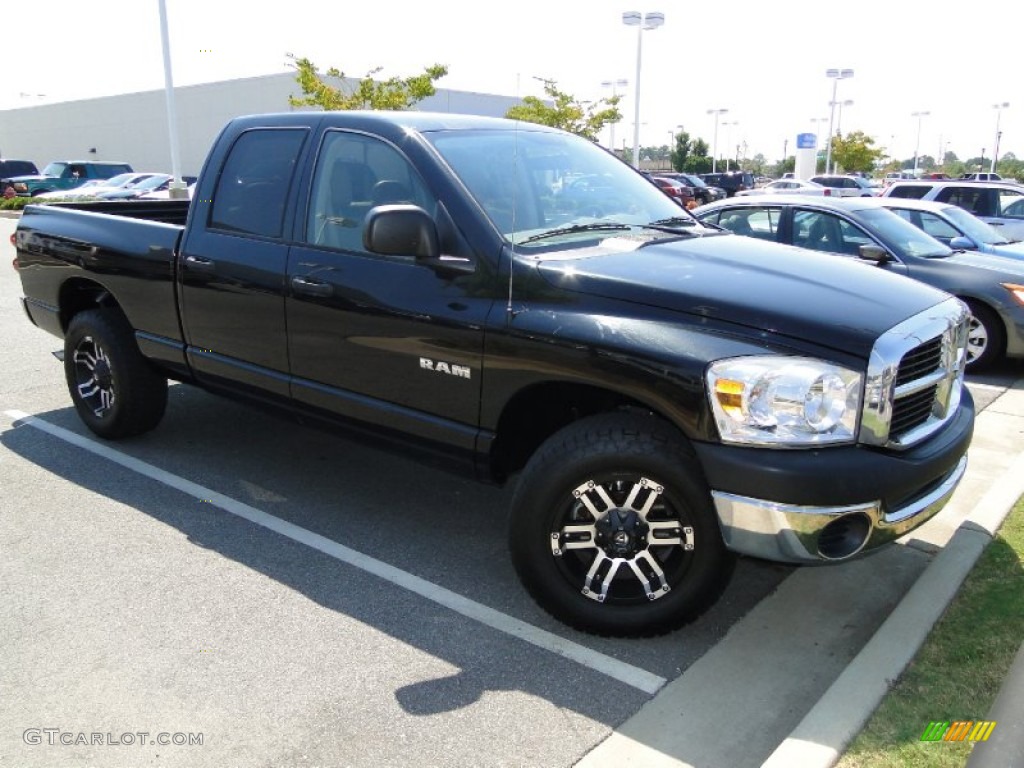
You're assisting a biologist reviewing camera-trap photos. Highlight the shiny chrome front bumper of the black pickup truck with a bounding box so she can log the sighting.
[712,456,967,563]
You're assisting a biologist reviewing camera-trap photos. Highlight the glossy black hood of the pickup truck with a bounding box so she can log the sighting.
[538,234,948,358]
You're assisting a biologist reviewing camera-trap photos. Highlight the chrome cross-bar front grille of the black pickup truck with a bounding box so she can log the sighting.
[860,299,970,449]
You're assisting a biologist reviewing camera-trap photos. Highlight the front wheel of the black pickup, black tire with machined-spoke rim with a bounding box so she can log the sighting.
[509,414,734,637]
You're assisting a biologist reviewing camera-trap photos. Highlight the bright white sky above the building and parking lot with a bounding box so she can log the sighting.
[0,0,1024,166]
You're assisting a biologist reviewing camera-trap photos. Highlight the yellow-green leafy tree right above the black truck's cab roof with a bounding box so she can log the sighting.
[288,53,447,111]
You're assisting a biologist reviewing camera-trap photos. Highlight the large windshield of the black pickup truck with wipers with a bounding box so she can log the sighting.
[426,127,701,248]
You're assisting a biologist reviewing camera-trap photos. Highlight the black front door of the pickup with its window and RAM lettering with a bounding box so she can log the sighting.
[286,130,493,450]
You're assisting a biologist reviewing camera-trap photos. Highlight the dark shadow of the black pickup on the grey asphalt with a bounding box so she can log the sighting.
[0,386,792,727]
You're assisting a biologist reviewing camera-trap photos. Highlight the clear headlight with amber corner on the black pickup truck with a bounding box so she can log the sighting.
[708,355,863,446]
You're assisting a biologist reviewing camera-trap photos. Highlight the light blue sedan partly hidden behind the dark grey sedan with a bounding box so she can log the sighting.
[884,198,1024,259]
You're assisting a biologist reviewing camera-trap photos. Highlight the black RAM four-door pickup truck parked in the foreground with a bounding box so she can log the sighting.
[14,113,974,635]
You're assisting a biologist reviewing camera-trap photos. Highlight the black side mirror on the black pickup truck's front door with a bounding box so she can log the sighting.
[362,204,474,273]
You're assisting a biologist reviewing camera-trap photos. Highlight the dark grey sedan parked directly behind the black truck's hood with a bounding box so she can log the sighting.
[693,195,1024,370]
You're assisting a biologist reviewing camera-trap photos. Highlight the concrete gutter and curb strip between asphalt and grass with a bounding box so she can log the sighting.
[578,380,1024,768]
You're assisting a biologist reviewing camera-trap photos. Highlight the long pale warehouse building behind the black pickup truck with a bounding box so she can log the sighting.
[0,73,520,176]
